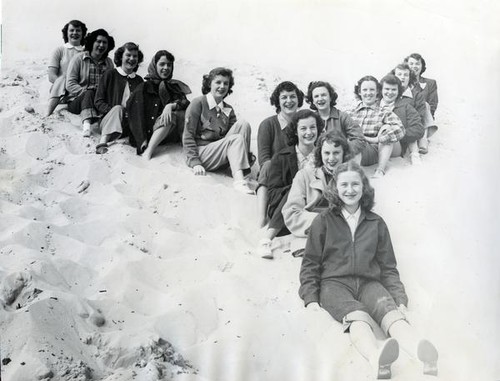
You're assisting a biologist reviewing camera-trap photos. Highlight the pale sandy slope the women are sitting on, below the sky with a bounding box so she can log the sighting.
[0,53,499,381]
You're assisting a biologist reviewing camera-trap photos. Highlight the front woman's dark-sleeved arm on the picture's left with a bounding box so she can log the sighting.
[299,215,326,307]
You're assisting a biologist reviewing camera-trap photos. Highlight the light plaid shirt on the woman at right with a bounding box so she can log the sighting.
[349,102,406,144]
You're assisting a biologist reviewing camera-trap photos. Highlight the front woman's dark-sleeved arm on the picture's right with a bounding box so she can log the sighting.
[376,219,408,306]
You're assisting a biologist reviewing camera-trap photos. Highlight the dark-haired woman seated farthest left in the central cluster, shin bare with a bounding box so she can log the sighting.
[257,81,304,228]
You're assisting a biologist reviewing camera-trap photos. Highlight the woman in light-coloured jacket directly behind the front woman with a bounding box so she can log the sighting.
[282,129,351,251]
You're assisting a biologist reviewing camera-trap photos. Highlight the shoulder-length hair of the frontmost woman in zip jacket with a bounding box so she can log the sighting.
[325,160,375,212]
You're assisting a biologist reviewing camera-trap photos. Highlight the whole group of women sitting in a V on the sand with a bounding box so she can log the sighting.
[48,20,438,378]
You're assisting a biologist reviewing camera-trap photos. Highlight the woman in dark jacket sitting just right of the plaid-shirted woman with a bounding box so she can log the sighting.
[380,74,424,164]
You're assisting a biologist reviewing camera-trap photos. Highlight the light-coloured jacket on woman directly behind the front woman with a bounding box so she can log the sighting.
[282,168,327,237]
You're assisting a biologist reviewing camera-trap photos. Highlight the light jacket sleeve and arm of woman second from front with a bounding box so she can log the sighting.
[281,170,318,237]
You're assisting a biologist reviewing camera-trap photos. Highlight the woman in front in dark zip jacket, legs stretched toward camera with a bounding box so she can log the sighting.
[299,161,438,379]
